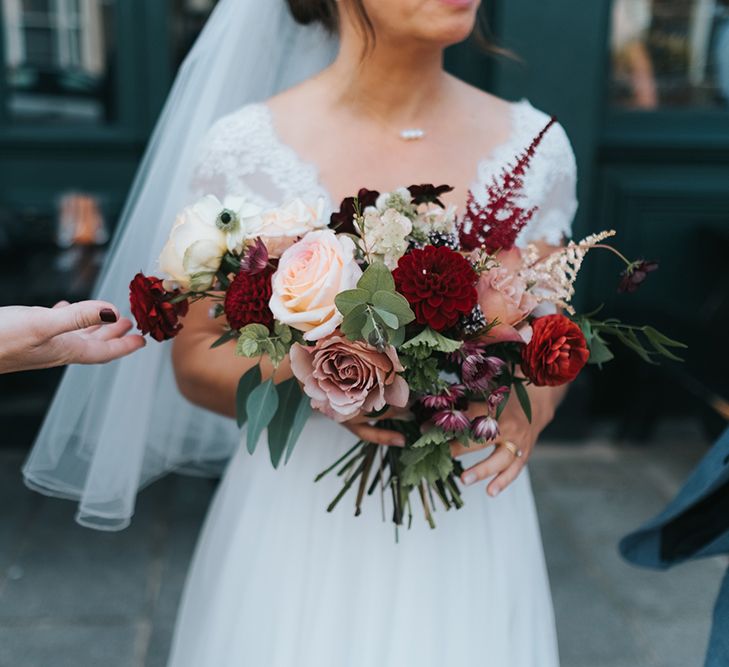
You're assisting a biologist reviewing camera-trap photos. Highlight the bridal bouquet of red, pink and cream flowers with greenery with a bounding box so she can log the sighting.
[131,117,681,526]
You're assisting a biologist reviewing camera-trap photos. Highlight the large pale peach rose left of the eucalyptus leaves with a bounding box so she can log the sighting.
[269,229,362,340]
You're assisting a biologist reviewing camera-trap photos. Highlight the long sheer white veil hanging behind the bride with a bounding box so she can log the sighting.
[23,0,336,530]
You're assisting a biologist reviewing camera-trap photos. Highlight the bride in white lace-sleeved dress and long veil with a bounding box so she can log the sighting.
[24,0,576,667]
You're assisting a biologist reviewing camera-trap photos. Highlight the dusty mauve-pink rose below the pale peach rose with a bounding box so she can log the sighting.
[290,334,410,422]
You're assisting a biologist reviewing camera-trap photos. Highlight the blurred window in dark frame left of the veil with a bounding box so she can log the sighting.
[2,0,117,124]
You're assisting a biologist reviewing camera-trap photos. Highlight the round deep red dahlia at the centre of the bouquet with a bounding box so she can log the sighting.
[392,245,478,331]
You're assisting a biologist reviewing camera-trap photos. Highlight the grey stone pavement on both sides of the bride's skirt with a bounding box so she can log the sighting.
[0,425,726,667]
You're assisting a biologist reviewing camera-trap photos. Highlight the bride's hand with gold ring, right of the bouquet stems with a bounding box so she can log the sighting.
[451,385,565,497]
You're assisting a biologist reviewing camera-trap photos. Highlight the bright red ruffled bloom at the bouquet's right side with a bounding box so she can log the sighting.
[521,315,590,387]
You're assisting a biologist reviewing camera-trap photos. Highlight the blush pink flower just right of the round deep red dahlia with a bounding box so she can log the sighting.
[477,248,538,343]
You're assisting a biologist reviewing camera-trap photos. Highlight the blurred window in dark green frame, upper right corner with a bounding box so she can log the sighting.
[610,0,729,109]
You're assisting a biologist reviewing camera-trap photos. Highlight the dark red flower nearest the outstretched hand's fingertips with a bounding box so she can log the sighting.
[129,273,188,342]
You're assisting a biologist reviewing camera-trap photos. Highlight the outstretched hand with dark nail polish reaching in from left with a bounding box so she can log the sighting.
[0,301,145,373]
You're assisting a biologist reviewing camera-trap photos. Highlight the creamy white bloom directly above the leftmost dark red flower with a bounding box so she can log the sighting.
[159,196,227,290]
